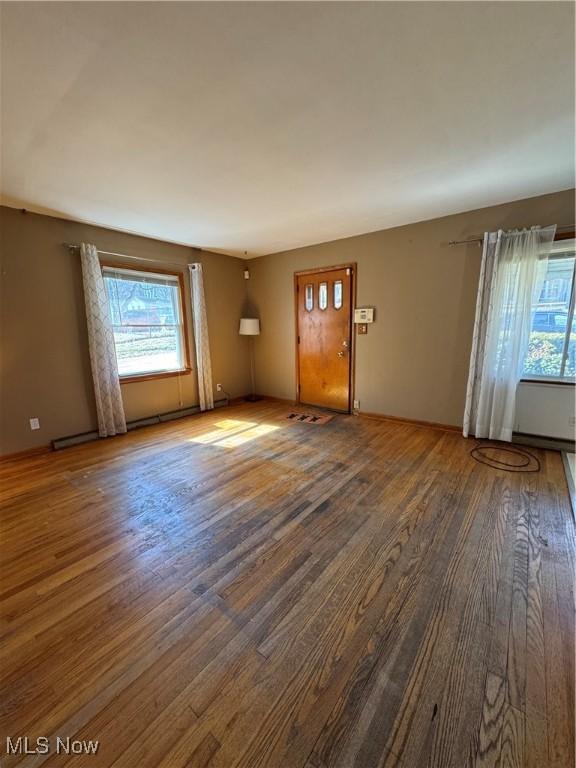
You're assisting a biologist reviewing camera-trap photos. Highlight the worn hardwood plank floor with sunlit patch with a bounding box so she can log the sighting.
[0,401,575,768]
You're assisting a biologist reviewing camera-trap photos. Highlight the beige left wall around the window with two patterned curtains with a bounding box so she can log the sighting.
[0,207,250,454]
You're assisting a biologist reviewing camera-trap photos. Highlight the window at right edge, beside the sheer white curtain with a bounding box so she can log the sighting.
[524,240,576,381]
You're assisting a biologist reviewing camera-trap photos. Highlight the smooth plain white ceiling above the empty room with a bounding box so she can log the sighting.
[0,2,574,256]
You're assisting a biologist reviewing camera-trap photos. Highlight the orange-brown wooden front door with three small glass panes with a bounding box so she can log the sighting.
[295,266,354,412]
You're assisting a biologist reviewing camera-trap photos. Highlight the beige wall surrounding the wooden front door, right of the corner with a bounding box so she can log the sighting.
[249,190,574,425]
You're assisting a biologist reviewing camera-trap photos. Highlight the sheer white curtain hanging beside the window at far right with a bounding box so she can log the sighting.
[463,226,556,442]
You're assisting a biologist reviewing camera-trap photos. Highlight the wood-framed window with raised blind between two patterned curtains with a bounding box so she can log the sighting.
[102,266,188,380]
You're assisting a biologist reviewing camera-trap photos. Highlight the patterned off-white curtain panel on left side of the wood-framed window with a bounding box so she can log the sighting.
[80,243,126,437]
